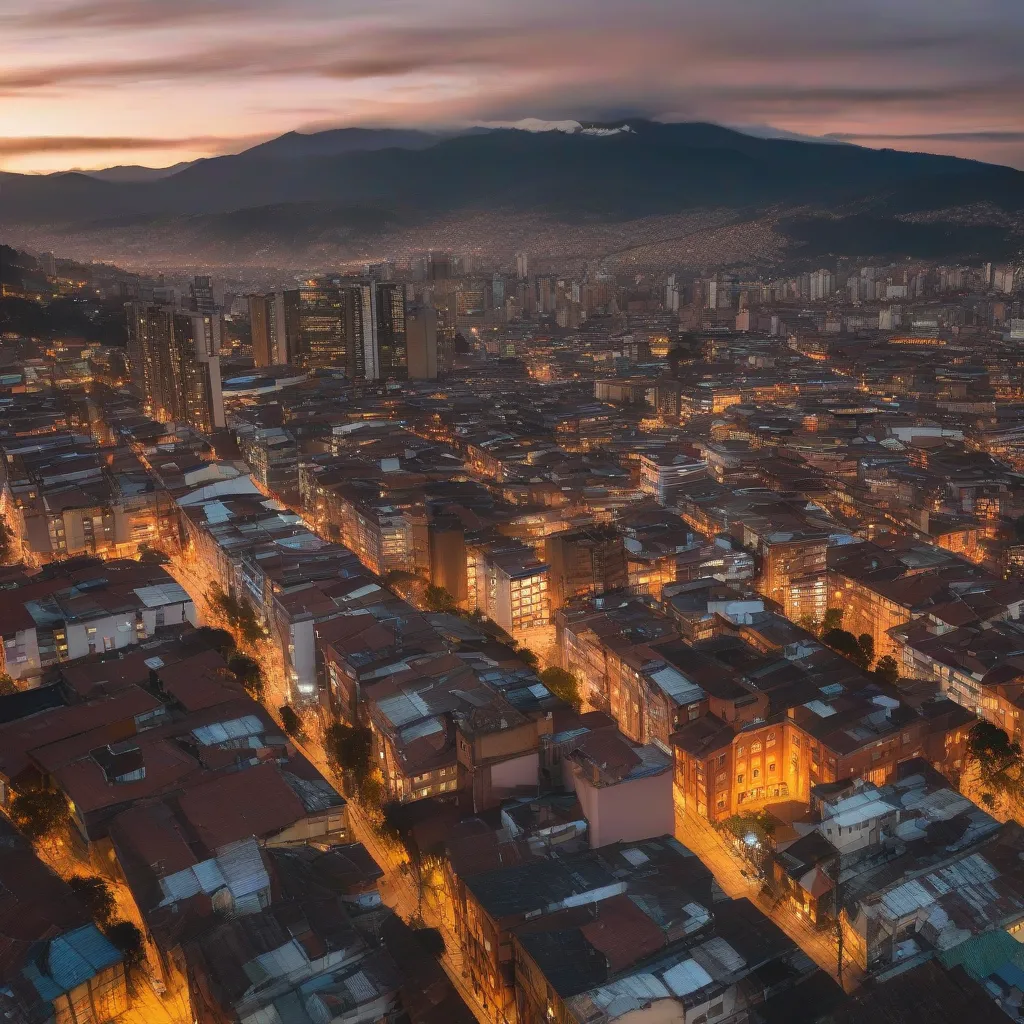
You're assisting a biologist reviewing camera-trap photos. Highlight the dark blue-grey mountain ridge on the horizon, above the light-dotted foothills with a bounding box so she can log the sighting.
[0,120,1024,268]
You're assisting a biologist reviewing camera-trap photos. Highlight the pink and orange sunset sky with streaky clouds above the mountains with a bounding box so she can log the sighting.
[0,0,1024,171]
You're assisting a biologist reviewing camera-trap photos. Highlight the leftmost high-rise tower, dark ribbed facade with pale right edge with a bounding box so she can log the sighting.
[125,302,224,433]
